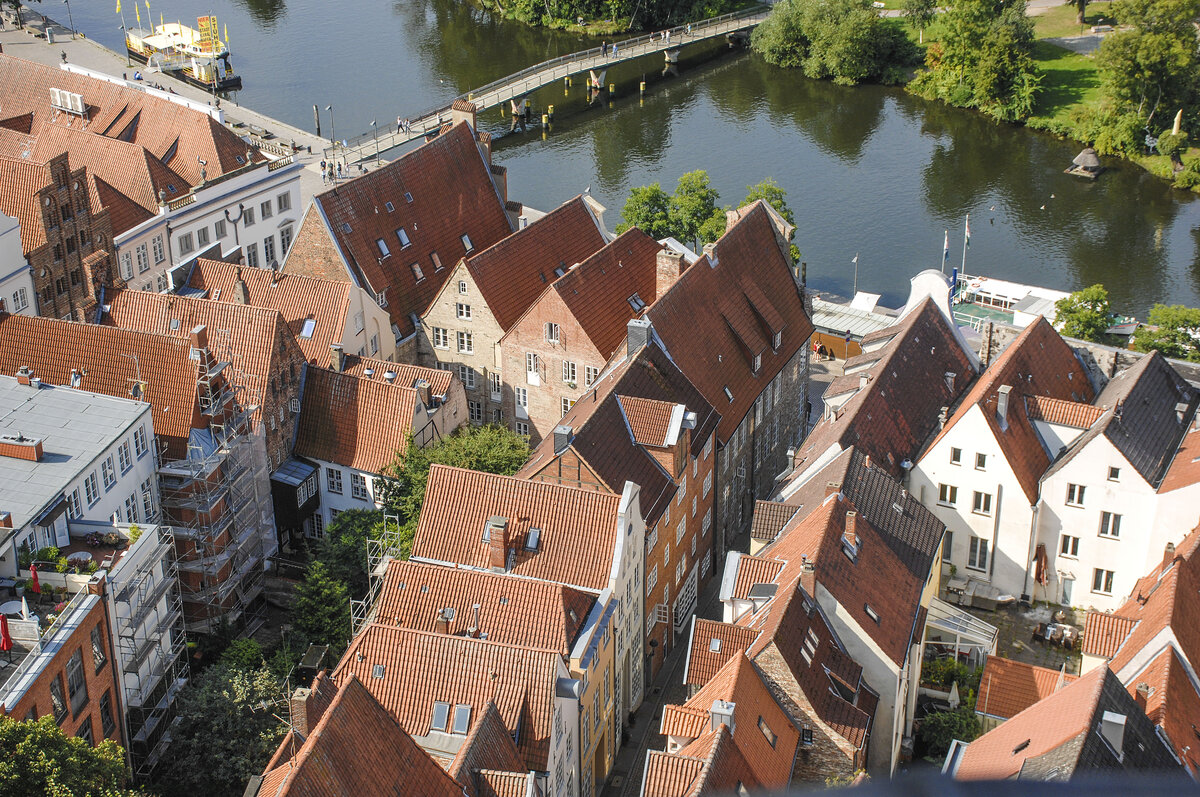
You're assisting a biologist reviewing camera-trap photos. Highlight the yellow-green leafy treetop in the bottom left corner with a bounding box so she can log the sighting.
[0,715,134,797]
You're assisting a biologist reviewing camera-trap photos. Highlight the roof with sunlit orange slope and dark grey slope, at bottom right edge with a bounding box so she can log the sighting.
[954,666,1178,780]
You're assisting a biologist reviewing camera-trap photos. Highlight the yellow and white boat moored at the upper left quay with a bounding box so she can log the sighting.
[125,17,241,91]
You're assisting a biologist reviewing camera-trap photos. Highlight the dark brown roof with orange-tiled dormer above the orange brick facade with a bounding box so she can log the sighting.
[518,342,720,527]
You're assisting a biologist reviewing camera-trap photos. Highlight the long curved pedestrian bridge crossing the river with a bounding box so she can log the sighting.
[329,7,770,163]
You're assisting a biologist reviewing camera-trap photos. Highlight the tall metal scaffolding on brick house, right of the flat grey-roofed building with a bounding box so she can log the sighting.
[158,330,275,634]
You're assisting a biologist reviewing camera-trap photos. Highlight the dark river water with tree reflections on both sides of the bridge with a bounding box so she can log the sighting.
[63,0,1200,317]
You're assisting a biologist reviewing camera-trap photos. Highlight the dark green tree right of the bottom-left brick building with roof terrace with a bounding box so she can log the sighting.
[145,664,286,797]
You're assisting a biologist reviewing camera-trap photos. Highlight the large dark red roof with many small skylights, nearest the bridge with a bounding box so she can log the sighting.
[304,122,512,337]
